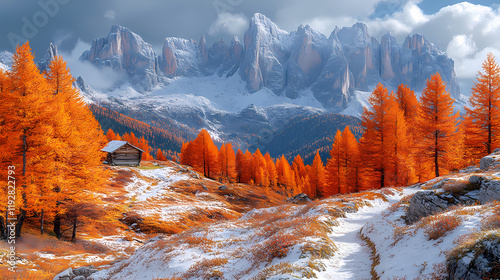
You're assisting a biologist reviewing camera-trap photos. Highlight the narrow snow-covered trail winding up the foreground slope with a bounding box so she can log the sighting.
[317,196,400,280]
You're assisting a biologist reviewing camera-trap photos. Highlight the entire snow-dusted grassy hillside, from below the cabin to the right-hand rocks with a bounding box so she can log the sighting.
[1,153,500,280]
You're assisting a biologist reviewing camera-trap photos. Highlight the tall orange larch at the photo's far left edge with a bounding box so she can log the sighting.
[2,43,56,237]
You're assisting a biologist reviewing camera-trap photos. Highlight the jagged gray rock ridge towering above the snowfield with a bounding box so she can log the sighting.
[81,13,460,111]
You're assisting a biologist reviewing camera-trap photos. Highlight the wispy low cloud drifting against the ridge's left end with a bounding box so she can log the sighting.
[61,39,127,91]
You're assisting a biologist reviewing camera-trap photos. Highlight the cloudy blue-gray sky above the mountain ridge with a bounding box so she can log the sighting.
[0,0,500,91]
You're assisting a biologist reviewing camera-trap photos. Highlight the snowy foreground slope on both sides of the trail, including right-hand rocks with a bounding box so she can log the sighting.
[86,151,500,280]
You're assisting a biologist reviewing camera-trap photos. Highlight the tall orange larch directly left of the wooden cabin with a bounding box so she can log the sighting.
[42,57,109,241]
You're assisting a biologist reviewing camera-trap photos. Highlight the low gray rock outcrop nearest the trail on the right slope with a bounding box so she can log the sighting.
[406,191,450,224]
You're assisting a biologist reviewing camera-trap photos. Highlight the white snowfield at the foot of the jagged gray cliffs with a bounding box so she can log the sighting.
[88,75,323,113]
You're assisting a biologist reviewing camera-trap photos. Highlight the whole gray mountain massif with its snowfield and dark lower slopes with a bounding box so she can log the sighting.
[0,13,464,162]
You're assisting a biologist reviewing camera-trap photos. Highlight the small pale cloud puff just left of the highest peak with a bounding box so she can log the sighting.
[208,13,248,36]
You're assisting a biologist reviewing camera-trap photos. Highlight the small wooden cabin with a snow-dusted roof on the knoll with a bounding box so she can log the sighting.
[101,140,144,166]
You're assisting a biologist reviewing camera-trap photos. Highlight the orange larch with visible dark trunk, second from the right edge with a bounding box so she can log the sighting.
[417,73,459,177]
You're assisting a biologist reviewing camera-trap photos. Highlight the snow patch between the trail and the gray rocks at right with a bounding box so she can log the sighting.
[362,189,491,279]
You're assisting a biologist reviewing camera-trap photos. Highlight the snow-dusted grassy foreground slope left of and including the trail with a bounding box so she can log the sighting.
[94,189,422,280]
